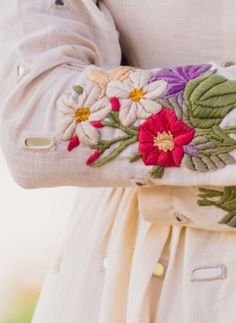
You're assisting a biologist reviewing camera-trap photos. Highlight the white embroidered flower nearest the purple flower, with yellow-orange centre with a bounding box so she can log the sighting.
[106,69,168,126]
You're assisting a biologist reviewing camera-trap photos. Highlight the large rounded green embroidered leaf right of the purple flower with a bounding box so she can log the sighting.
[184,74,236,129]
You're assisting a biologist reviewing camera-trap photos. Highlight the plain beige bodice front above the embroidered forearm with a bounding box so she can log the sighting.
[103,0,236,68]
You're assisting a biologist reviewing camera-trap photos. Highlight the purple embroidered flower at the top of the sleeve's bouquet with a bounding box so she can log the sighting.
[149,64,212,106]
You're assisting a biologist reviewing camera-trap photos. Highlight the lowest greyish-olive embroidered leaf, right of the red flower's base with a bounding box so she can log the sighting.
[183,153,236,172]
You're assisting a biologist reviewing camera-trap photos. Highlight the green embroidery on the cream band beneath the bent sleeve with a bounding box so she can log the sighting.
[197,186,236,228]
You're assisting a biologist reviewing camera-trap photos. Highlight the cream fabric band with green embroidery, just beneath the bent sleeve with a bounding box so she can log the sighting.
[138,186,236,231]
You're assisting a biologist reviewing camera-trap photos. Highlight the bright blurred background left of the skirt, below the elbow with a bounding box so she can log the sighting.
[0,151,78,323]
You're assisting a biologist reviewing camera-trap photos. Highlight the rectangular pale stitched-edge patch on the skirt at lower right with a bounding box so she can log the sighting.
[191,265,226,282]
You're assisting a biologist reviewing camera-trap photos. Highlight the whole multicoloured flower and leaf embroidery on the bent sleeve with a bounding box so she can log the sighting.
[58,64,236,178]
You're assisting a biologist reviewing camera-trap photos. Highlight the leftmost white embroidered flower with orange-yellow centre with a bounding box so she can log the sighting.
[57,85,111,145]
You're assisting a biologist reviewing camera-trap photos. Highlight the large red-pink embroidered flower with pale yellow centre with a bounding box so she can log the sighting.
[138,107,195,167]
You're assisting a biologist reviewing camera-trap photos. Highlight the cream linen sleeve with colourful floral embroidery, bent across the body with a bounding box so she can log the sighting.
[0,0,236,188]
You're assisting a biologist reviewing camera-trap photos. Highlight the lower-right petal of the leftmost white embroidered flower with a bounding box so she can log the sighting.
[76,121,100,145]
